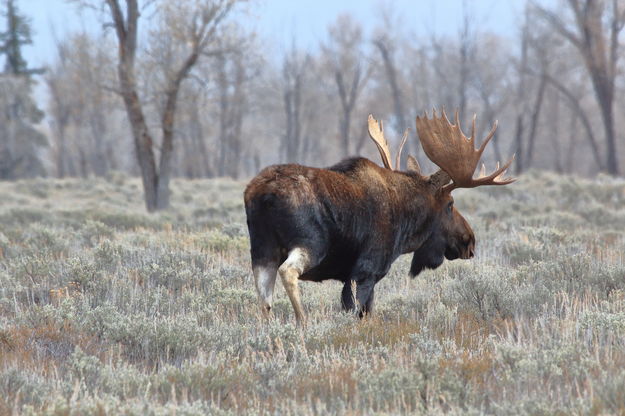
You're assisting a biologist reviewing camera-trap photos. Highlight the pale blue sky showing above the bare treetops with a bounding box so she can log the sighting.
[17,0,525,67]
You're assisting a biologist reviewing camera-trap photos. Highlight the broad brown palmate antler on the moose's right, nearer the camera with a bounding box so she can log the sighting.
[417,109,516,191]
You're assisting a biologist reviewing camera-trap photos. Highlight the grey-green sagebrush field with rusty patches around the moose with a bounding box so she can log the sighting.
[0,173,625,415]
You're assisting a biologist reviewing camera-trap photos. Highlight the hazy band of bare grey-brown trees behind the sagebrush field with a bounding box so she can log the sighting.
[0,0,625,185]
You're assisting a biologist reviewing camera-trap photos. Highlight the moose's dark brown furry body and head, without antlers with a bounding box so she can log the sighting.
[245,158,475,315]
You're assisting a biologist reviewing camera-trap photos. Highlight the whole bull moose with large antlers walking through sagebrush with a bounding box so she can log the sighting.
[244,110,515,325]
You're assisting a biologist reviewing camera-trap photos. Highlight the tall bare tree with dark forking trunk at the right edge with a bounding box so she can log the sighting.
[533,0,625,175]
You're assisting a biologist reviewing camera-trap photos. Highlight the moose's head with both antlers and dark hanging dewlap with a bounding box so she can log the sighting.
[369,109,516,276]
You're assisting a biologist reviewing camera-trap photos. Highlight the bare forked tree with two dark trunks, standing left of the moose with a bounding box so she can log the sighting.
[101,0,242,212]
